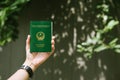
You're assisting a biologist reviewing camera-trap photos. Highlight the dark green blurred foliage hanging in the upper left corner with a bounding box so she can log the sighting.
[0,0,30,46]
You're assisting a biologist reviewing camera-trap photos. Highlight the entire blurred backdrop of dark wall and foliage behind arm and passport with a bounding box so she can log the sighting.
[0,0,120,80]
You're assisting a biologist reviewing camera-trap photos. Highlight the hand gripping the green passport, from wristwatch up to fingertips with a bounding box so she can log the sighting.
[24,35,55,71]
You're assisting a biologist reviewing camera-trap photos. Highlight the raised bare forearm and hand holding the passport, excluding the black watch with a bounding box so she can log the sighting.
[8,35,55,80]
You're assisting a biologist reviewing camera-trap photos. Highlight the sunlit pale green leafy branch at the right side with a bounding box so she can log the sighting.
[77,3,120,58]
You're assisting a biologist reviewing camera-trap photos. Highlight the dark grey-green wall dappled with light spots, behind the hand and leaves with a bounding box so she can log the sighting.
[0,0,120,80]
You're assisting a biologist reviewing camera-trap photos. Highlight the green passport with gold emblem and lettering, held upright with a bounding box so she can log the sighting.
[30,21,53,52]
